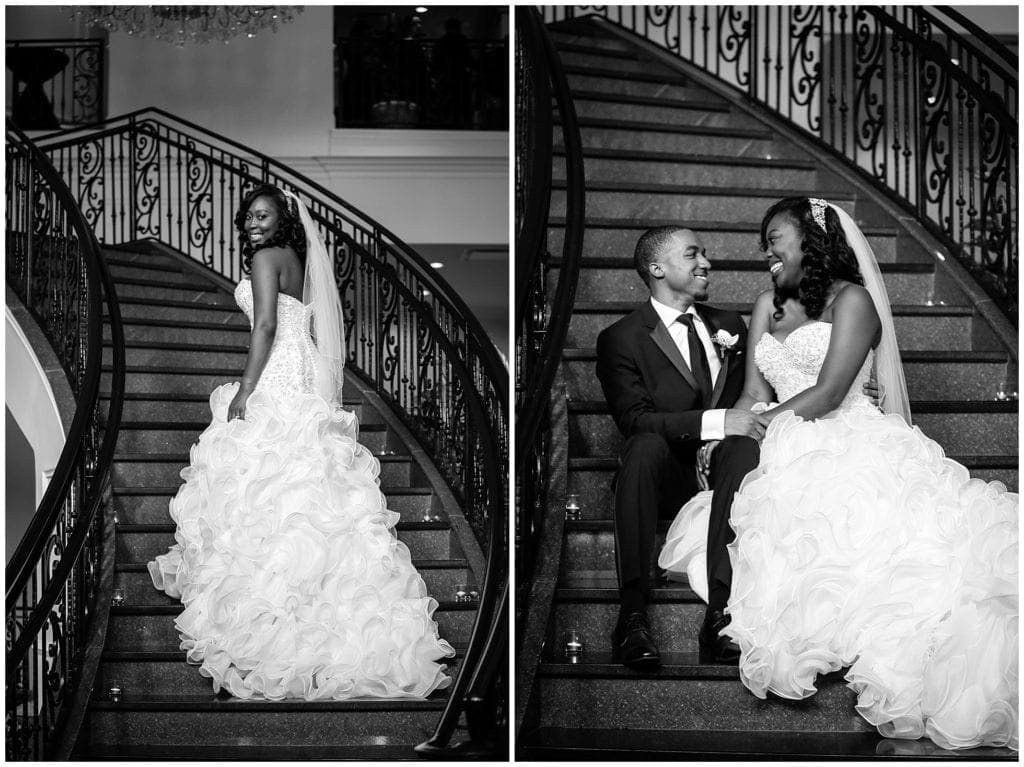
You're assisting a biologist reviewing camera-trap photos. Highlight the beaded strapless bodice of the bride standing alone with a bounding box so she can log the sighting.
[234,279,316,396]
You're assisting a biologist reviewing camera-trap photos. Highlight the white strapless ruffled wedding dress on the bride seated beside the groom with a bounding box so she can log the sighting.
[658,321,1018,749]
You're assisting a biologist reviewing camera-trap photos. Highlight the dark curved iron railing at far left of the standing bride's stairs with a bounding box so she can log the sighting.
[5,124,124,761]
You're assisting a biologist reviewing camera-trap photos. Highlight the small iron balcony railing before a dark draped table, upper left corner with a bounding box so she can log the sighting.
[7,38,106,130]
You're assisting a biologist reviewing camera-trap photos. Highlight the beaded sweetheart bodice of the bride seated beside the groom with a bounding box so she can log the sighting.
[754,321,881,415]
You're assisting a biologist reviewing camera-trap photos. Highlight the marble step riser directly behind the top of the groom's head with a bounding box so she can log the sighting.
[548,215,909,266]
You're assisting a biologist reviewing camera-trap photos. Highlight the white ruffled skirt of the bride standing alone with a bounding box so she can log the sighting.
[148,383,455,700]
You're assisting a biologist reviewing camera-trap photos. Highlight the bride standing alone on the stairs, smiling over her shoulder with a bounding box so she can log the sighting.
[148,185,455,700]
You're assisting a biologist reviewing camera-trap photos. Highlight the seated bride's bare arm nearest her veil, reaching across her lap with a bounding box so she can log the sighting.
[761,285,882,426]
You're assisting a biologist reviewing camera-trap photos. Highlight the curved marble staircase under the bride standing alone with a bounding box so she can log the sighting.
[73,243,483,761]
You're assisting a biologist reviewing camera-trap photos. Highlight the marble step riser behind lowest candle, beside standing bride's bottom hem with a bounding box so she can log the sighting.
[93,649,465,702]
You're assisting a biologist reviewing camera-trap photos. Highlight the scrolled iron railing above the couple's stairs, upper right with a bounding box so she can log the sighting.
[545,5,1019,322]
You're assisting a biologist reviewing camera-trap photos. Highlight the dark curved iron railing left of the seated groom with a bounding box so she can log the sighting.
[515,7,586,628]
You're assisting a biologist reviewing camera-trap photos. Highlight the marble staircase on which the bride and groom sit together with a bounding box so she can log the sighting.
[518,19,1018,761]
